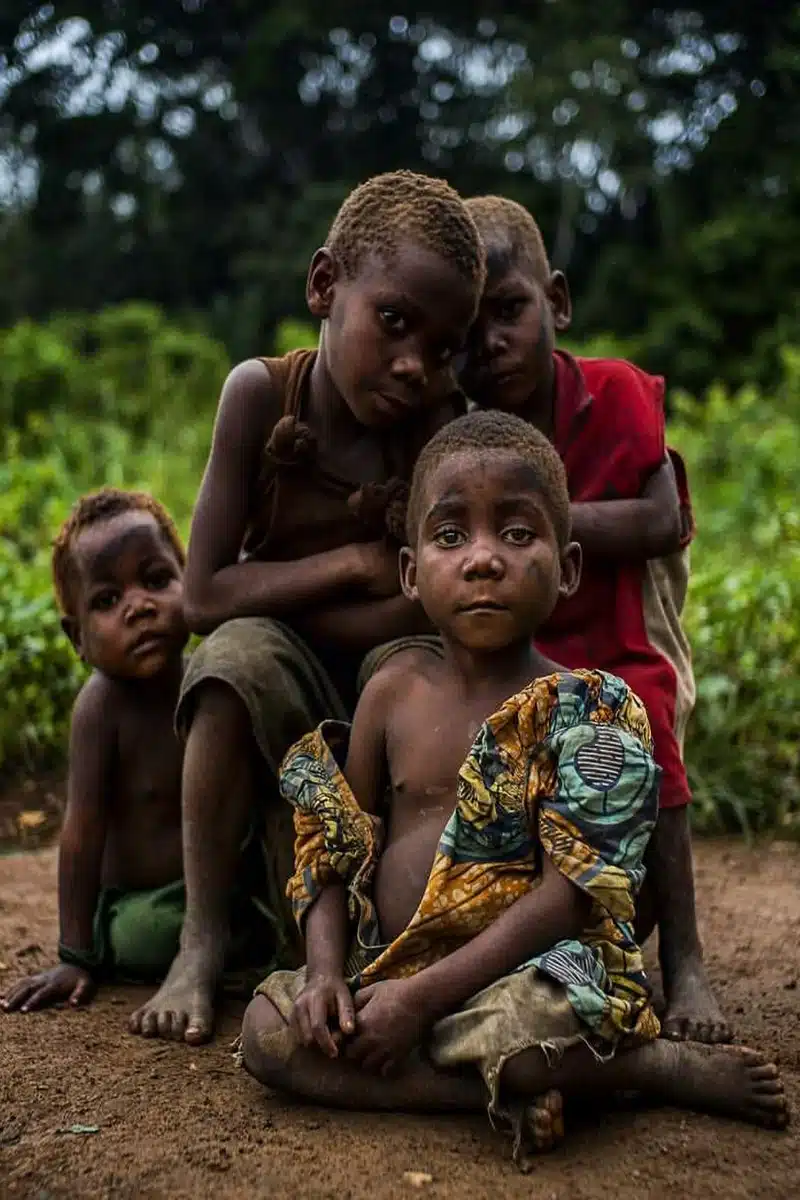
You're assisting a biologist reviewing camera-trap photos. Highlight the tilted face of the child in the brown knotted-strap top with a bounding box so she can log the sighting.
[308,241,476,428]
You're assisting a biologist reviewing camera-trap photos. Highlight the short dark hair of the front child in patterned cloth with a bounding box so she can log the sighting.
[405,409,571,550]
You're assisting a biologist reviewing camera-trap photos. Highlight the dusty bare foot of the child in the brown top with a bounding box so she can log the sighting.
[128,950,217,1045]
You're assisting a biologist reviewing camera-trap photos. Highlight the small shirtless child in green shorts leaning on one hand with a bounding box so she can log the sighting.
[2,488,188,1013]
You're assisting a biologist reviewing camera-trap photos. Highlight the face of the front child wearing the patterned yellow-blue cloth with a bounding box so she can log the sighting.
[401,450,581,652]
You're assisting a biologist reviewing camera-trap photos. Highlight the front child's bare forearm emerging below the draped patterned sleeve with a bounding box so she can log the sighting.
[408,856,590,1020]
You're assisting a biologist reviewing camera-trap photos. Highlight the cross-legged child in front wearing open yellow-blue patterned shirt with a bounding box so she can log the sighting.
[241,413,786,1157]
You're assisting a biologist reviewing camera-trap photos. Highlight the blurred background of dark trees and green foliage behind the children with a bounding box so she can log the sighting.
[0,7,800,834]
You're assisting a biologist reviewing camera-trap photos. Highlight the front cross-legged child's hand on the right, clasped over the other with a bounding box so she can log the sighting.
[345,979,433,1075]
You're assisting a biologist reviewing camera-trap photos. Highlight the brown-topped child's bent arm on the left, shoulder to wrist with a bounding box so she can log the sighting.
[185,360,362,634]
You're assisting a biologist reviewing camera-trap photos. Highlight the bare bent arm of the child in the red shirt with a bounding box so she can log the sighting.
[570,458,681,559]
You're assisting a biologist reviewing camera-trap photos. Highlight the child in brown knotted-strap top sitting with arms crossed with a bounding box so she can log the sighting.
[132,172,485,1043]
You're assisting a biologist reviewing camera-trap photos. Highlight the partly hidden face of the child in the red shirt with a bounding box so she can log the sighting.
[461,253,571,413]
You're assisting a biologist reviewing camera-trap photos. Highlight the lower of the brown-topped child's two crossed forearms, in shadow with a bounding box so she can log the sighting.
[294,593,433,654]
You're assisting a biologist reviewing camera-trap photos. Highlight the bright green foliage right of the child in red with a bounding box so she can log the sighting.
[669,349,800,832]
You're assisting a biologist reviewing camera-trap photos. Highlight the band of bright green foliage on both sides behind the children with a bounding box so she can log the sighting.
[0,306,800,833]
